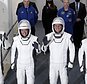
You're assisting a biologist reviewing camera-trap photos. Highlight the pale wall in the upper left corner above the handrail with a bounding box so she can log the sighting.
[0,0,18,32]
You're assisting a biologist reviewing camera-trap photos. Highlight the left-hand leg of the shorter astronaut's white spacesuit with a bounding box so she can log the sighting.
[17,68,25,84]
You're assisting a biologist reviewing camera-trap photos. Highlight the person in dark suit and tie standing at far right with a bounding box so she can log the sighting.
[69,0,86,50]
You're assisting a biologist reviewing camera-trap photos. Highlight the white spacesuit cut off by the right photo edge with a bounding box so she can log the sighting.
[78,38,87,84]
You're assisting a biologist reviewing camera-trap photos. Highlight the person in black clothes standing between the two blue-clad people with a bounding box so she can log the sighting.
[42,0,57,34]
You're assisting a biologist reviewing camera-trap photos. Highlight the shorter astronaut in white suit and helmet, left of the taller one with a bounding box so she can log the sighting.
[11,20,40,84]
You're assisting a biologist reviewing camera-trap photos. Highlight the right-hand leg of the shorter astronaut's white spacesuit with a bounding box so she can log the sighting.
[26,66,34,84]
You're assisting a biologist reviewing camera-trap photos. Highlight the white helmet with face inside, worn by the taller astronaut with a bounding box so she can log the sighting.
[52,17,65,38]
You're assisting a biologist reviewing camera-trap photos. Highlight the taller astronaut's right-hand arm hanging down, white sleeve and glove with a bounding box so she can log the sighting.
[68,38,75,68]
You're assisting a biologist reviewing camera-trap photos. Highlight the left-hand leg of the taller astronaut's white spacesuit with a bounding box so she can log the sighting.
[49,64,58,84]
